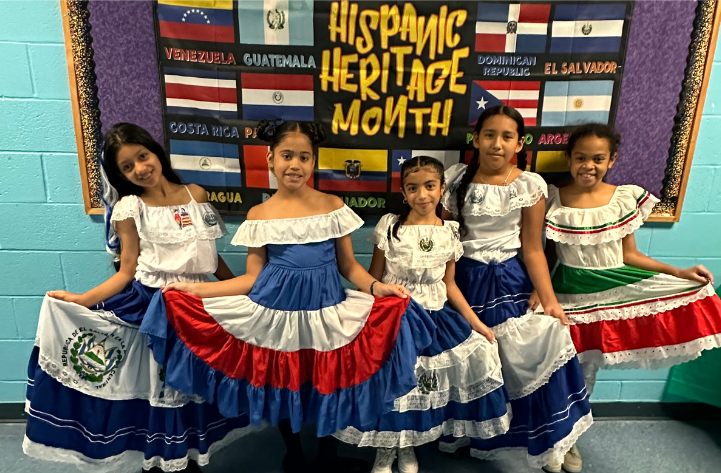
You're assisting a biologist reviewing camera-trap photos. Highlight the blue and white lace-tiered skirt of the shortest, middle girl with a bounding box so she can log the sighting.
[334,302,511,448]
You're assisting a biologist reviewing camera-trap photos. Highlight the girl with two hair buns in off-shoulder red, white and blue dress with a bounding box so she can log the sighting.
[151,121,435,473]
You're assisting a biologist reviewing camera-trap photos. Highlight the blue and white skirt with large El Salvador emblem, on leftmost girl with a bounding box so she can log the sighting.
[23,281,257,471]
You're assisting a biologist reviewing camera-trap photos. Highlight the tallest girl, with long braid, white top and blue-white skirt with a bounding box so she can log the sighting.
[441,106,592,467]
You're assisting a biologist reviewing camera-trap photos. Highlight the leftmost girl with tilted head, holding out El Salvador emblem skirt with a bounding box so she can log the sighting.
[23,123,250,472]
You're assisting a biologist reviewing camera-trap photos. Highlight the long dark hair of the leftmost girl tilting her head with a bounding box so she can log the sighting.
[103,123,183,198]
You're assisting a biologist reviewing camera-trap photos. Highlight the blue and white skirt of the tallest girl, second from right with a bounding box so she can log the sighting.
[440,257,593,467]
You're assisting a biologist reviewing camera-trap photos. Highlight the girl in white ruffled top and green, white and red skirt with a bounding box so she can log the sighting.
[546,124,721,392]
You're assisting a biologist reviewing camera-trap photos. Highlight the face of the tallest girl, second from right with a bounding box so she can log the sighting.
[473,114,523,171]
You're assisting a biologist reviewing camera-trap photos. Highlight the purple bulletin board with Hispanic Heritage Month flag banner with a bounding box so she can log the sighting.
[62,0,718,221]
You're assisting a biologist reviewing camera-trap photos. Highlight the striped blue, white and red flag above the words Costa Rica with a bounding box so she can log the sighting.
[164,67,238,119]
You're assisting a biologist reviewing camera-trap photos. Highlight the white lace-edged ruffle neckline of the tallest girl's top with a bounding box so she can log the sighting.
[441,163,548,217]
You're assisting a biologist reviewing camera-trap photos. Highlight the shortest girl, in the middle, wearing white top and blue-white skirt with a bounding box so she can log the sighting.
[335,156,511,473]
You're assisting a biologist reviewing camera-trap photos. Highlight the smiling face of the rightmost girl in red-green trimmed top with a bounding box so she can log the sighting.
[566,135,616,188]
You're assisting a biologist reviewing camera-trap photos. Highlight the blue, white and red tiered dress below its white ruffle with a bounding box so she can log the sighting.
[141,240,435,436]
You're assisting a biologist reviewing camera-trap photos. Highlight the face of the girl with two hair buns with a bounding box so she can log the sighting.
[267,132,315,190]
